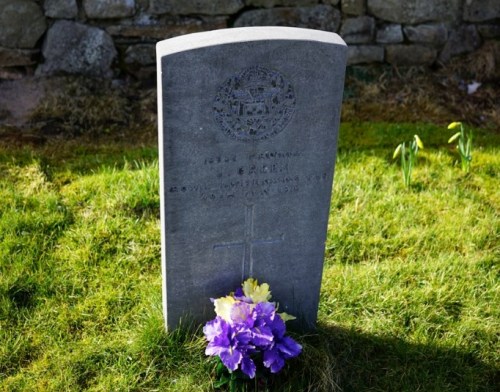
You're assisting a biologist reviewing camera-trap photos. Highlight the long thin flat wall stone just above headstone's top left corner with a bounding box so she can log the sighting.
[106,18,227,40]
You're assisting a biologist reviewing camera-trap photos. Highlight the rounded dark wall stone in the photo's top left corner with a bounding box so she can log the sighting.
[0,0,47,49]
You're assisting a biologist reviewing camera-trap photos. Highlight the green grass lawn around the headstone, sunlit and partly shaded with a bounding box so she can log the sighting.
[0,123,500,391]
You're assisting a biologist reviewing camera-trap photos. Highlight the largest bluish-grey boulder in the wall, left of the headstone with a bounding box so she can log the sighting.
[37,20,117,77]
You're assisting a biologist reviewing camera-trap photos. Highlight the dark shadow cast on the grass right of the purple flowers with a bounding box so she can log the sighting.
[283,325,500,392]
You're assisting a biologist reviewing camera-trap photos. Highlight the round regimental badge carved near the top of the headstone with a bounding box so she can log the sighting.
[213,67,295,142]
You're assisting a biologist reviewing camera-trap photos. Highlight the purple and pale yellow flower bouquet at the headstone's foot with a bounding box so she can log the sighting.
[203,278,302,390]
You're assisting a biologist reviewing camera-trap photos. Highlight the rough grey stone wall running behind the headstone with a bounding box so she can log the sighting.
[0,0,500,79]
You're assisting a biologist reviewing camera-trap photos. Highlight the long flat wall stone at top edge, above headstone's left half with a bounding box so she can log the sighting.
[149,0,244,15]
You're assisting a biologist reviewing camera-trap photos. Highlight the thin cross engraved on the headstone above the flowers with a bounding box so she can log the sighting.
[213,204,285,281]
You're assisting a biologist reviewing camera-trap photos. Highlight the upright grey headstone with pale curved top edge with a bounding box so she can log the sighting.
[157,27,347,329]
